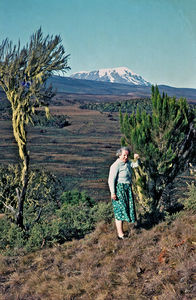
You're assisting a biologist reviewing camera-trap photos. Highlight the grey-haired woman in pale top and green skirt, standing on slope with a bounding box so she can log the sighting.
[108,147,139,240]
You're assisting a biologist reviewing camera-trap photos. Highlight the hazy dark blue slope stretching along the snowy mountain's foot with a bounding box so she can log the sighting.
[48,76,196,103]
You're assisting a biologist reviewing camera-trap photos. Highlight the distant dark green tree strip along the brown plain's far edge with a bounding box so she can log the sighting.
[80,99,152,113]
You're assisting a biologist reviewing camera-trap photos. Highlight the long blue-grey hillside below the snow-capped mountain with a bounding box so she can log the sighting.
[0,76,196,104]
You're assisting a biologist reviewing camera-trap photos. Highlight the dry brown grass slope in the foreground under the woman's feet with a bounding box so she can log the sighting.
[0,214,196,300]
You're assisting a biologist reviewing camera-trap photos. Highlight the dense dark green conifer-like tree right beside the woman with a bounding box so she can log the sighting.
[120,86,195,213]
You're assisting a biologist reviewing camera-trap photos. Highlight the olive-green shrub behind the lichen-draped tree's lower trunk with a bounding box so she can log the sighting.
[0,165,63,219]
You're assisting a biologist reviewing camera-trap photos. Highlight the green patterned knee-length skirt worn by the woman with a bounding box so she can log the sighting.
[112,183,136,223]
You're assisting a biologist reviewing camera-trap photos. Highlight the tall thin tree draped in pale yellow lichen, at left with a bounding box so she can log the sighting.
[0,28,70,228]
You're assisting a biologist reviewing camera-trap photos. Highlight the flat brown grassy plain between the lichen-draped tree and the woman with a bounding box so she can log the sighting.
[0,96,120,200]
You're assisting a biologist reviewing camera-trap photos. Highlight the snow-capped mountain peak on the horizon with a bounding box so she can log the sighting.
[70,67,151,86]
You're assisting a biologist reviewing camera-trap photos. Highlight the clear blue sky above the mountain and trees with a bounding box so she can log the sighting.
[0,0,196,88]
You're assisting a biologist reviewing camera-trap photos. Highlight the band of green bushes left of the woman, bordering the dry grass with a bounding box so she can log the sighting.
[0,165,113,255]
